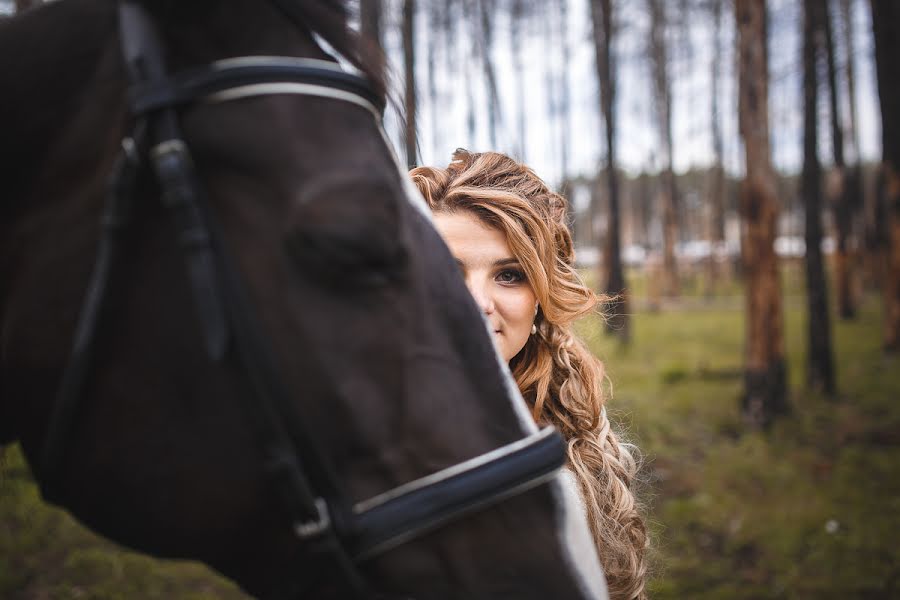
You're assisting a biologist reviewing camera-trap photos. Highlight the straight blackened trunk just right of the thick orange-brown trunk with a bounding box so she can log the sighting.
[802,0,840,395]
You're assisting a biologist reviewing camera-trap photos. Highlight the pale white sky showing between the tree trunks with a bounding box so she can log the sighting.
[376,0,881,188]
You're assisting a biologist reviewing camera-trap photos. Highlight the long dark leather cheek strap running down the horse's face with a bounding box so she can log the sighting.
[119,0,370,598]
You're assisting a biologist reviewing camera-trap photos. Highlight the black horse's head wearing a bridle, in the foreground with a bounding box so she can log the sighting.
[0,0,605,599]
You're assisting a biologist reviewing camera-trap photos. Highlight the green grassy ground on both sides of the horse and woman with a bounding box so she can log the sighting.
[0,272,900,600]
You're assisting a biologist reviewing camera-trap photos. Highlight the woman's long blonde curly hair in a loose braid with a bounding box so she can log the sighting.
[410,149,648,600]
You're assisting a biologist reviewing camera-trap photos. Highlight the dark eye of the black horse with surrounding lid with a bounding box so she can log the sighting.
[285,177,406,287]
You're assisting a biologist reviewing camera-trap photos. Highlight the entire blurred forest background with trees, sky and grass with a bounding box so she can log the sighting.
[0,0,900,599]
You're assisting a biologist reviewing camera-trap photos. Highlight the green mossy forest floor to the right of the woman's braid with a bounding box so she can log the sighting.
[580,276,900,600]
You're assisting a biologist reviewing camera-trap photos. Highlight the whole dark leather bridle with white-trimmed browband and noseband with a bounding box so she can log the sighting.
[40,0,566,598]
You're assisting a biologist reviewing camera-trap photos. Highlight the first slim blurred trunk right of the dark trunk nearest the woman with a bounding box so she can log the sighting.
[647,0,679,296]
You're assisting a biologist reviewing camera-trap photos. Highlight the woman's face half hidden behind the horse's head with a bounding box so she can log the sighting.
[434,210,537,362]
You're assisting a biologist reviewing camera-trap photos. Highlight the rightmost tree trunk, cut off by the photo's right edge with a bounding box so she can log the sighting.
[871,0,900,354]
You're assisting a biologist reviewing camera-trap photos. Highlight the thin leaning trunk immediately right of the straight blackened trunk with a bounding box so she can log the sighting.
[818,0,856,319]
